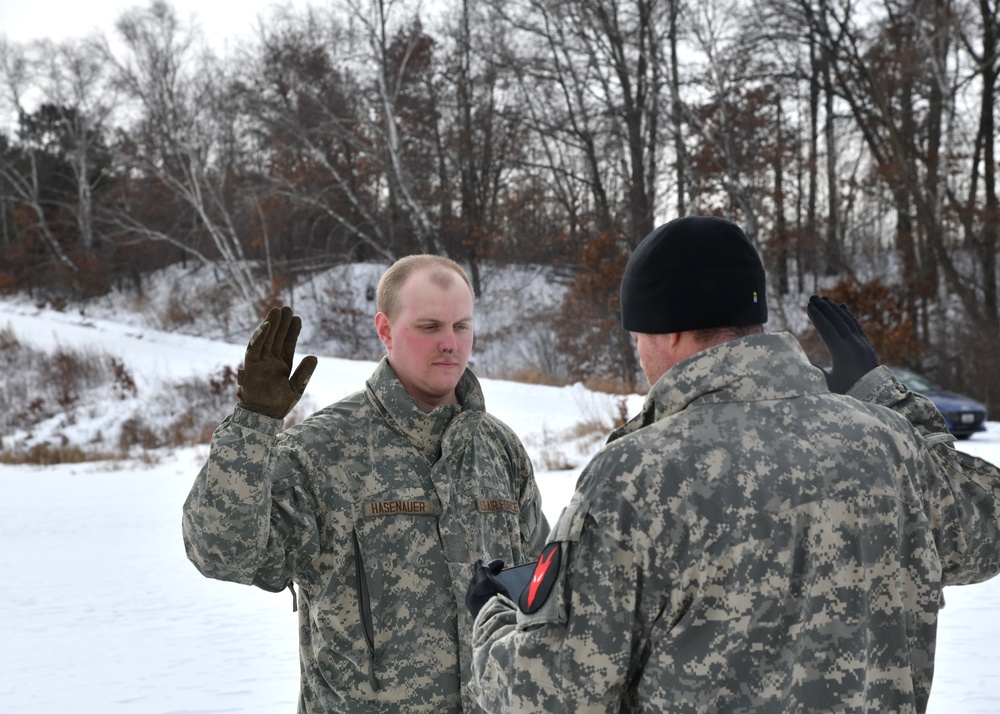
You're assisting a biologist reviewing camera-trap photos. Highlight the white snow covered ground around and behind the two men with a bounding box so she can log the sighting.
[0,300,1000,714]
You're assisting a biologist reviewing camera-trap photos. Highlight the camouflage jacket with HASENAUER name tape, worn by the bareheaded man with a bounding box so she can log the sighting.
[183,359,549,714]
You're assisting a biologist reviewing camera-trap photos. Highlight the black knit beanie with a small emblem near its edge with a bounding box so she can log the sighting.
[621,216,767,334]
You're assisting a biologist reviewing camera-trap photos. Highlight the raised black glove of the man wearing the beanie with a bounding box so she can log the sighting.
[806,295,878,394]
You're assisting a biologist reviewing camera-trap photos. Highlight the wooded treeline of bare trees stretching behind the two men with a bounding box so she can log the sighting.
[0,0,1000,406]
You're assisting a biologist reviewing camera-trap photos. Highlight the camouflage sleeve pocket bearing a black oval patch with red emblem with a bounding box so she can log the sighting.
[517,494,593,630]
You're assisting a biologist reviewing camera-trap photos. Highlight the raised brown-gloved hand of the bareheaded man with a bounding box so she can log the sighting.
[236,307,317,419]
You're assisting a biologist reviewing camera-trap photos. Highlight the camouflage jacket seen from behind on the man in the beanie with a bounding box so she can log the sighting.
[473,333,1000,714]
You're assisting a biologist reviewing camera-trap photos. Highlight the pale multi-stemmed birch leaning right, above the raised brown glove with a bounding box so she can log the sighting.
[100,0,270,310]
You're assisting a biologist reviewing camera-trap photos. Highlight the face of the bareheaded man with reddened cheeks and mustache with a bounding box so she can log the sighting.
[375,269,472,412]
